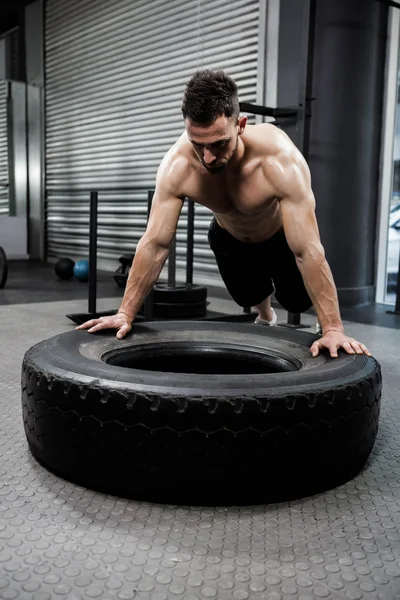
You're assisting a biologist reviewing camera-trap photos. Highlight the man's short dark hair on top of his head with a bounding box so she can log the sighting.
[182,69,240,125]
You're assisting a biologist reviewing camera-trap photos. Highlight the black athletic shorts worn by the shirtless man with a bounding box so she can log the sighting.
[208,218,312,313]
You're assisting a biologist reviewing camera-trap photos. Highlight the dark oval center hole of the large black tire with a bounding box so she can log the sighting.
[102,343,300,375]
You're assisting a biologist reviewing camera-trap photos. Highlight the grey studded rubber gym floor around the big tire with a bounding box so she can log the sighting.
[0,263,400,600]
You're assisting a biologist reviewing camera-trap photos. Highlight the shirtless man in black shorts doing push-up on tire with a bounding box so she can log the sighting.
[77,70,371,357]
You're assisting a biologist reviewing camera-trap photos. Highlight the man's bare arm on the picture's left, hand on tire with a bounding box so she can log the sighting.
[77,154,187,338]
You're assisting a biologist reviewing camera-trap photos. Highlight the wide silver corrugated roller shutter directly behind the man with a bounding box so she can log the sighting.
[45,0,260,275]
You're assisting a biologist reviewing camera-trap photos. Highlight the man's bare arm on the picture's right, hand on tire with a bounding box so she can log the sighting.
[269,150,371,357]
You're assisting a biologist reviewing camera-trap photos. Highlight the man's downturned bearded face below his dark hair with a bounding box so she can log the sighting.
[185,116,246,173]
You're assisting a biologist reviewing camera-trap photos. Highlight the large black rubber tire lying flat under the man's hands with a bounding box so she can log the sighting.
[22,321,382,506]
